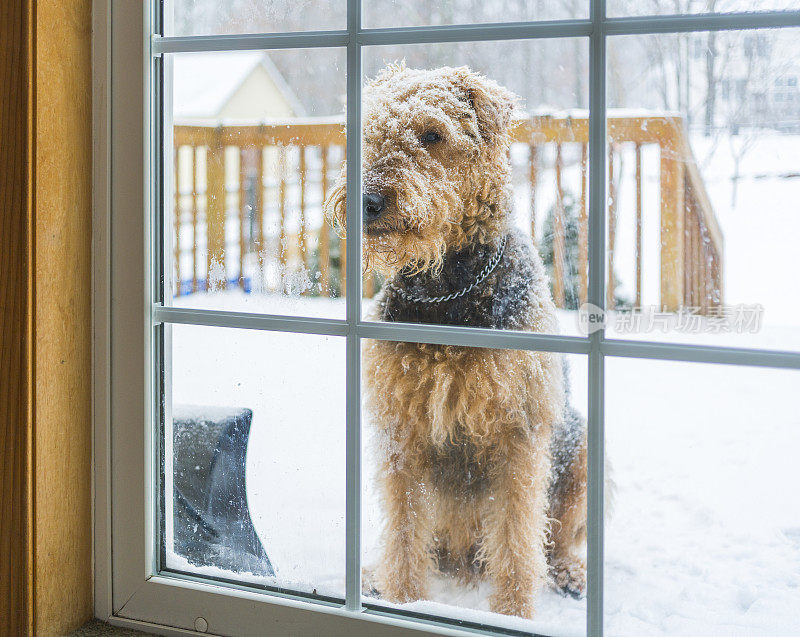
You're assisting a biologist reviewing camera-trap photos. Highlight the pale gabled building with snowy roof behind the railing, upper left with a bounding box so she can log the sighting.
[172,51,306,123]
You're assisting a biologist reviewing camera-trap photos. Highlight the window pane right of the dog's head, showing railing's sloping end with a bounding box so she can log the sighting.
[607,29,800,349]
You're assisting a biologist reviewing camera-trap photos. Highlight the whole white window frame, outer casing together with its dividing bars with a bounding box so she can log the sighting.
[93,0,800,637]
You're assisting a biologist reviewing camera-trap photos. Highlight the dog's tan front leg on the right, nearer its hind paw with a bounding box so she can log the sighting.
[479,433,549,617]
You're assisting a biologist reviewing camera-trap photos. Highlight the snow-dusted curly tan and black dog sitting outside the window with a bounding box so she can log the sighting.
[326,65,586,617]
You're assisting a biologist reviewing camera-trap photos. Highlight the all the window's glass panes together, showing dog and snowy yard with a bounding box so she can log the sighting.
[147,0,800,636]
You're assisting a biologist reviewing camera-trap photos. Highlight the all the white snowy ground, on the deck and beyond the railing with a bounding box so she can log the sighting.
[169,134,800,636]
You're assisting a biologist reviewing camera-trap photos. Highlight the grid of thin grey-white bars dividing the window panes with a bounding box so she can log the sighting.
[150,0,800,637]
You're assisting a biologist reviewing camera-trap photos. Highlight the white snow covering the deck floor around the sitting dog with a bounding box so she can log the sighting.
[170,292,800,635]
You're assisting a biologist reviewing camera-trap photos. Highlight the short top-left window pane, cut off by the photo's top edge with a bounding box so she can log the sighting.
[164,0,346,35]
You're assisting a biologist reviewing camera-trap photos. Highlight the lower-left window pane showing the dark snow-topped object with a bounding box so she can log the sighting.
[162,325,345,598]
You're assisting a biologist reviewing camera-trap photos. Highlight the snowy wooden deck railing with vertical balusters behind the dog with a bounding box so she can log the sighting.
[173,111,723,313]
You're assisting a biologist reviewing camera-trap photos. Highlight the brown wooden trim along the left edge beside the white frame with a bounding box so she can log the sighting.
[0,0,93,636]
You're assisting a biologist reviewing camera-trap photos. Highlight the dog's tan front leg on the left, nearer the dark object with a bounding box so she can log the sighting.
[378,463,432,603]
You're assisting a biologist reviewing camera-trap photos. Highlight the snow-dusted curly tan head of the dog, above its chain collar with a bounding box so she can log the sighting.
[326,65,515,273]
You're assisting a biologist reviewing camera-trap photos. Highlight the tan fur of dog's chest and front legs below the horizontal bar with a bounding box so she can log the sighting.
[364,341,564,616]
